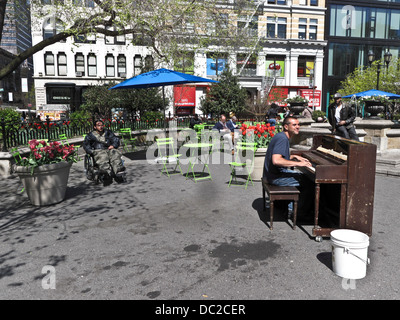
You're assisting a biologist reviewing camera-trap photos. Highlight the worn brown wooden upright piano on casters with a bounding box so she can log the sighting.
[292,135,376,237]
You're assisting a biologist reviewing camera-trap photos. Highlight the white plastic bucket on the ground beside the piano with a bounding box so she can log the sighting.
[331,229,369,279]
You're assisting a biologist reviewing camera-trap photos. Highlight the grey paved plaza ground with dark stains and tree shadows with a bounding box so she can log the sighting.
[0,152,400,300]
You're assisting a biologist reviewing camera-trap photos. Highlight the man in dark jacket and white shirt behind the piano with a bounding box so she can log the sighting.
[328,93,359,141]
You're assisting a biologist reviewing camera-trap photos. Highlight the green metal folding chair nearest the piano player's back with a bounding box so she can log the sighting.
[228,142,257,189]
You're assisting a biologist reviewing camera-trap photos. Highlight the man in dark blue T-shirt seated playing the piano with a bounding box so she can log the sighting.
[263,116,314,219]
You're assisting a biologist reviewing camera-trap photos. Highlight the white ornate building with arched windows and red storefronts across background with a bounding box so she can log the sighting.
[32,0,326,115]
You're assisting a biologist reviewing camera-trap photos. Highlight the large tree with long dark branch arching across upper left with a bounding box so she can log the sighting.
[0,0,258,79]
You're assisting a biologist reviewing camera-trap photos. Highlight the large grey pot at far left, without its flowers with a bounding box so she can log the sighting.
[15,161,72,206]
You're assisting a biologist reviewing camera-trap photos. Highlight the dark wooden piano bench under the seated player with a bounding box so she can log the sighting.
[261,177,300,230]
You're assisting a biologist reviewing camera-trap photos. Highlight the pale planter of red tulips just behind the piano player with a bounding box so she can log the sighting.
[241,123,277,181]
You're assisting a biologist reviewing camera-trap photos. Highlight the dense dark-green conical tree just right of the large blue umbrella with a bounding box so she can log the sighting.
[200,67,247,115]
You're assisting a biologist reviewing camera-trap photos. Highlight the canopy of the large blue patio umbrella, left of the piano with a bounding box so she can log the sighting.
[110,69,218,90]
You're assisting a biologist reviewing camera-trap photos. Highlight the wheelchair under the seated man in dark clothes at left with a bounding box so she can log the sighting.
[84,153,126,185]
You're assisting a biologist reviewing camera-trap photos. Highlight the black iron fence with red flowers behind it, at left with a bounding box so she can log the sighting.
[0,117,189,152]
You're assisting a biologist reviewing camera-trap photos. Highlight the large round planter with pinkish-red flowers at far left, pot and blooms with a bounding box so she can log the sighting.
[14,140,77,206]
